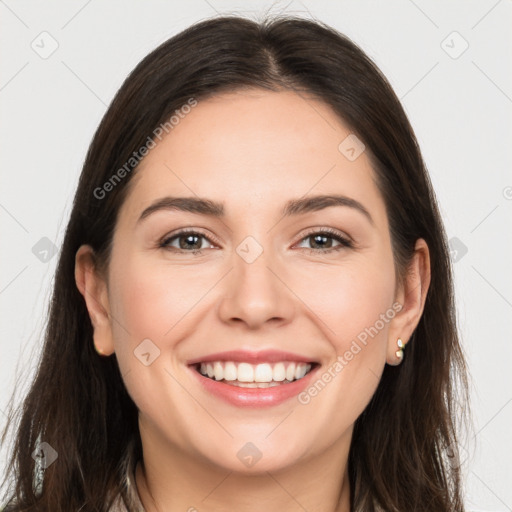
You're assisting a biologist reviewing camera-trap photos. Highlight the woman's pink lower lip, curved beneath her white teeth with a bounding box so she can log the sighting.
[189,366,319,408]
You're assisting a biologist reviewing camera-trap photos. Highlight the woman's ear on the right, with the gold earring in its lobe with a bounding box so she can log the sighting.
[386,238,430,366]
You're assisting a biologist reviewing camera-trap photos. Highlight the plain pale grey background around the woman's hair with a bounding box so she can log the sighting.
[0,0,512,511]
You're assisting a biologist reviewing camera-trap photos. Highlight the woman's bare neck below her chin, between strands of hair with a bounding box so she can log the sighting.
[135,428,350,512]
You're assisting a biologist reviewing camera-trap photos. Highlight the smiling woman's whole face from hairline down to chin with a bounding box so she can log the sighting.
[78,90,412,472]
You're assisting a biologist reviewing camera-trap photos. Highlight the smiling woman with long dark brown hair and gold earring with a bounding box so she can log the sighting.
[0,17,465,512]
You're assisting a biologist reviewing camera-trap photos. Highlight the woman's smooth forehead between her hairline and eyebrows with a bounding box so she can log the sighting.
[123,89,383,222]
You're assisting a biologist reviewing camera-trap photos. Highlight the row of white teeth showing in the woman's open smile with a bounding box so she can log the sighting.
[199,361,311,388]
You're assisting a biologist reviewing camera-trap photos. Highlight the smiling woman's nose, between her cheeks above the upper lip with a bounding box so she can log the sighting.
[218,245,295,330]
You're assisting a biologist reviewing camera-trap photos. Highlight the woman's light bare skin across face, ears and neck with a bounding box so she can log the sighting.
[76,90,430,512]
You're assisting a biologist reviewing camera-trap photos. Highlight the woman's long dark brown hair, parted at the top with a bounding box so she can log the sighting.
[4,16,466,512]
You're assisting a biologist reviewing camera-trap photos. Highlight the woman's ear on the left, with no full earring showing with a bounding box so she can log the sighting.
[75,245,114,356]
